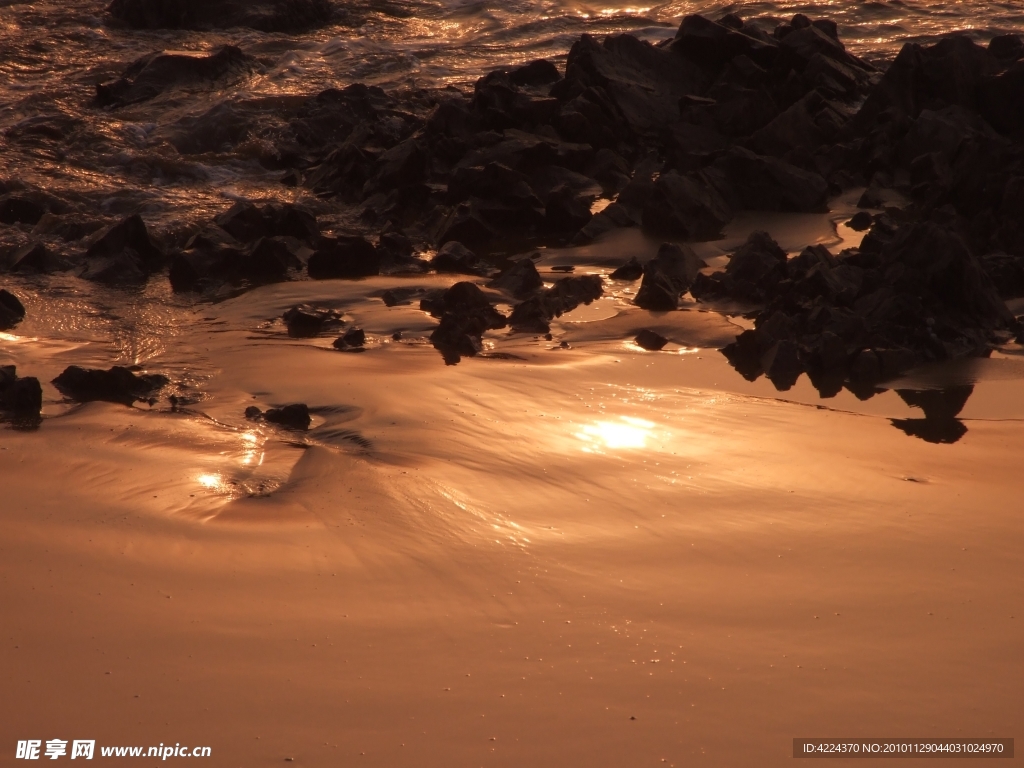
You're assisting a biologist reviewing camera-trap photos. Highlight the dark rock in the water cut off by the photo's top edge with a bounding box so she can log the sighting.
[106,0,334,32]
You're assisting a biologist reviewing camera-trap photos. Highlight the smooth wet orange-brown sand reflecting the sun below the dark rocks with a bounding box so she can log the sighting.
[0,211,1024,766]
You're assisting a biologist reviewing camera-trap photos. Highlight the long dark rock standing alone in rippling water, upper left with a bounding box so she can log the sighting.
[96,45,261,106]
